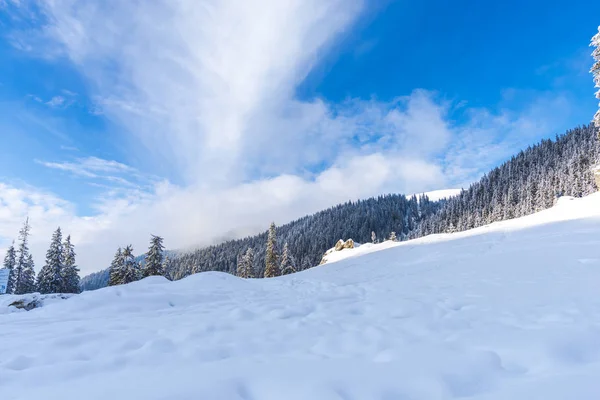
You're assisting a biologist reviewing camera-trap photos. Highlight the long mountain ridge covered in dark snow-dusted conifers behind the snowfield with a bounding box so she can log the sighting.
[82,126,600,290]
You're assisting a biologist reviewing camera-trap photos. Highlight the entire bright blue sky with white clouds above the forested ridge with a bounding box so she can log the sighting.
[0,0,600,271]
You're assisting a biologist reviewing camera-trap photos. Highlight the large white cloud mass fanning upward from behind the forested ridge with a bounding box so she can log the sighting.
[0,0,580,272]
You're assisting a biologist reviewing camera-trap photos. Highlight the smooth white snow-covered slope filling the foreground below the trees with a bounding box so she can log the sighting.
[0,194,600,400]
